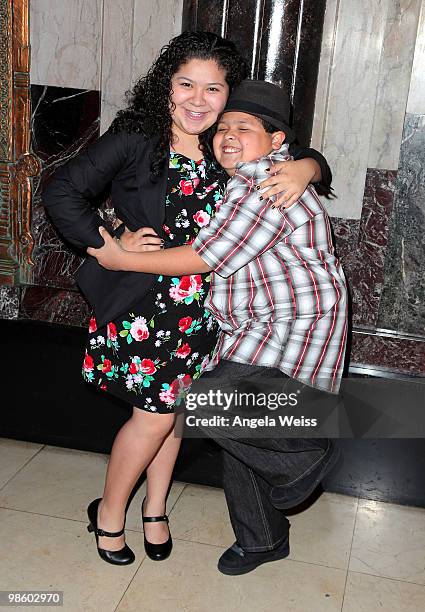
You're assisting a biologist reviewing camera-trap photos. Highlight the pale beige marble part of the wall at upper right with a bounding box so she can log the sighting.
[312,0,423,219]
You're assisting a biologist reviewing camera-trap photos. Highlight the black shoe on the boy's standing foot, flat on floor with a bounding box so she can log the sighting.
[217,536,289,576]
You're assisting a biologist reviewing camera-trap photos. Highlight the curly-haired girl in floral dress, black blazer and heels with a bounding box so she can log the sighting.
[44,32,330,565]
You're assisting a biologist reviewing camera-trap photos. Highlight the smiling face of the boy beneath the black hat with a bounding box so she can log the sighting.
[213,111,285,176]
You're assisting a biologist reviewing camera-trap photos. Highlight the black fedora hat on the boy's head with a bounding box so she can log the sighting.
[223,79,295,143]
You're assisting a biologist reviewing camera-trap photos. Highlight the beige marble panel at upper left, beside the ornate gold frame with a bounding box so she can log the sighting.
[30,0,103,90]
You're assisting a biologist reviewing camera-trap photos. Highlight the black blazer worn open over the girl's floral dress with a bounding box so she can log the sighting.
[43,132,332,327]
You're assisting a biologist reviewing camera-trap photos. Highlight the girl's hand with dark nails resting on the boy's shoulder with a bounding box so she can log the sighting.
[259,157,320,208]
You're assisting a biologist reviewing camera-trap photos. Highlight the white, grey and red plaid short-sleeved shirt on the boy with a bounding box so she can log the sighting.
[193,145,347,393]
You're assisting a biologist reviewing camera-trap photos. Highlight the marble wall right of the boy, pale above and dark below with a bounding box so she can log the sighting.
[312,0,425,374]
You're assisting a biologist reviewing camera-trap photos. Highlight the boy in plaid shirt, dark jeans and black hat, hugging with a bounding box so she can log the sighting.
[88,81,347,575]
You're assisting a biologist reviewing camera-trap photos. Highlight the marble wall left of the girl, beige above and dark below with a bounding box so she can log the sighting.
[11,0,182,325]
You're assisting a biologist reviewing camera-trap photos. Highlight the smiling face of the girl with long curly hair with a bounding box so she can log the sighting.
[171,59,229,146]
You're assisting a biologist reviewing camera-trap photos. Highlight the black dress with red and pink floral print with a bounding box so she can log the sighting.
[82,153,225,413]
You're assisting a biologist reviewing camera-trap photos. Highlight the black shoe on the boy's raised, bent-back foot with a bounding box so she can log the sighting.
[270,442,341,510]
